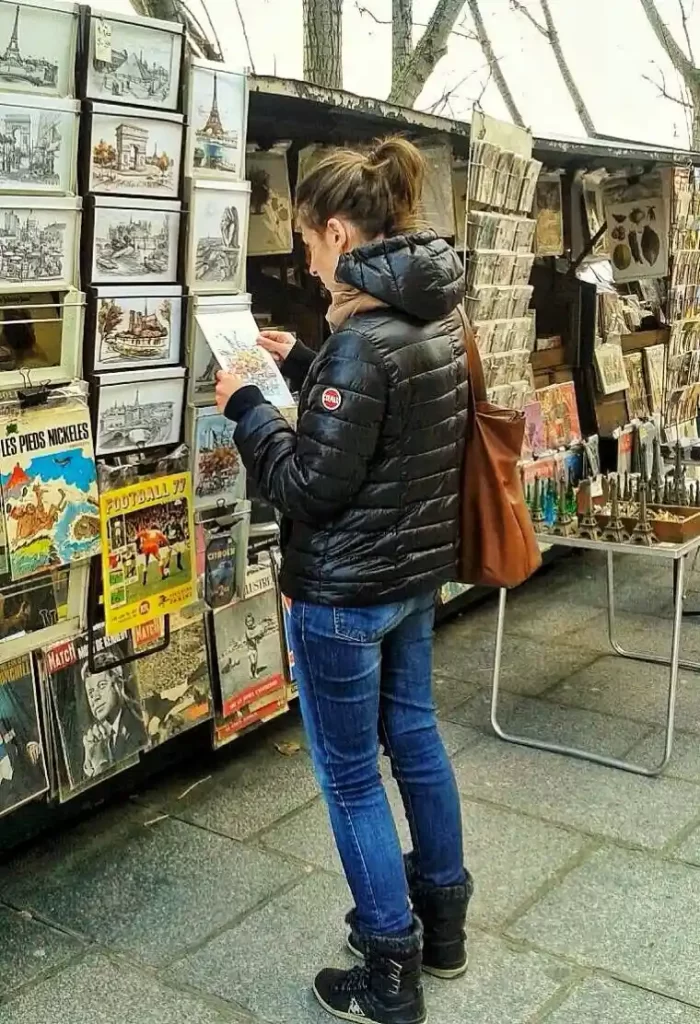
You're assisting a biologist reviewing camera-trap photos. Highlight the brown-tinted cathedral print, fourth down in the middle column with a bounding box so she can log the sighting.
[85,285,184,373]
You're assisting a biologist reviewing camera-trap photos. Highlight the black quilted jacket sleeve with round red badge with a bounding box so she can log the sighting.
[226,331,387,523]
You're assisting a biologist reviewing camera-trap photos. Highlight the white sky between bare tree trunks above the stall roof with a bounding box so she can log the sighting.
[105,0,700,147]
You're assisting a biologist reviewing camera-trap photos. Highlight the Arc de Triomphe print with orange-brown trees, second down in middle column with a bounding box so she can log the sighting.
[81,103,184,199]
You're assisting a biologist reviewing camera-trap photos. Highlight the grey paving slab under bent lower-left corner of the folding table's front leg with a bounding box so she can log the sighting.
[452,691,649,757]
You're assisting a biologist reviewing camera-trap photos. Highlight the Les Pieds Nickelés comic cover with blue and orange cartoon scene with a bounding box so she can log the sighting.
[0,400,99,580]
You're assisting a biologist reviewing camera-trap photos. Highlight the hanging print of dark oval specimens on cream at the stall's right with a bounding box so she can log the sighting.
[606,196,668,282]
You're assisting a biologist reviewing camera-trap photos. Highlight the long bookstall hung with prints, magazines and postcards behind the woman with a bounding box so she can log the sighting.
[0,0,700,849]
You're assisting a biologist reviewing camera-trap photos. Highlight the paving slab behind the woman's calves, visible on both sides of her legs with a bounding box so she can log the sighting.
[259,786,589,927]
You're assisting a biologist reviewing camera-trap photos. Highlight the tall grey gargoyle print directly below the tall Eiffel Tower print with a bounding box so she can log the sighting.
[186,181,251,295]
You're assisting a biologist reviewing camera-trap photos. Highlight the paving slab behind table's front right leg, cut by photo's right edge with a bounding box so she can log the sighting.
[546,655,700,732]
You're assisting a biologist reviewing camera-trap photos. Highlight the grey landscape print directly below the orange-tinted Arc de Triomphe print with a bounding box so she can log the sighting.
[93,206,180,283]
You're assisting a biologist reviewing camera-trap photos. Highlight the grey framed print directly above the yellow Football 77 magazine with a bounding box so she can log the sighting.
[95,367,185,456]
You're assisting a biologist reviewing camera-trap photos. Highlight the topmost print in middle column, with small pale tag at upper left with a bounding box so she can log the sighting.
[87,16,182,110]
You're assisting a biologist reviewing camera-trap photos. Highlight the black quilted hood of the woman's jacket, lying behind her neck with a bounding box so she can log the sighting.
[336,231,465,323]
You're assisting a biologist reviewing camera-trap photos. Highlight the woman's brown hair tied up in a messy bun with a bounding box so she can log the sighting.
[297,135,426,239]
